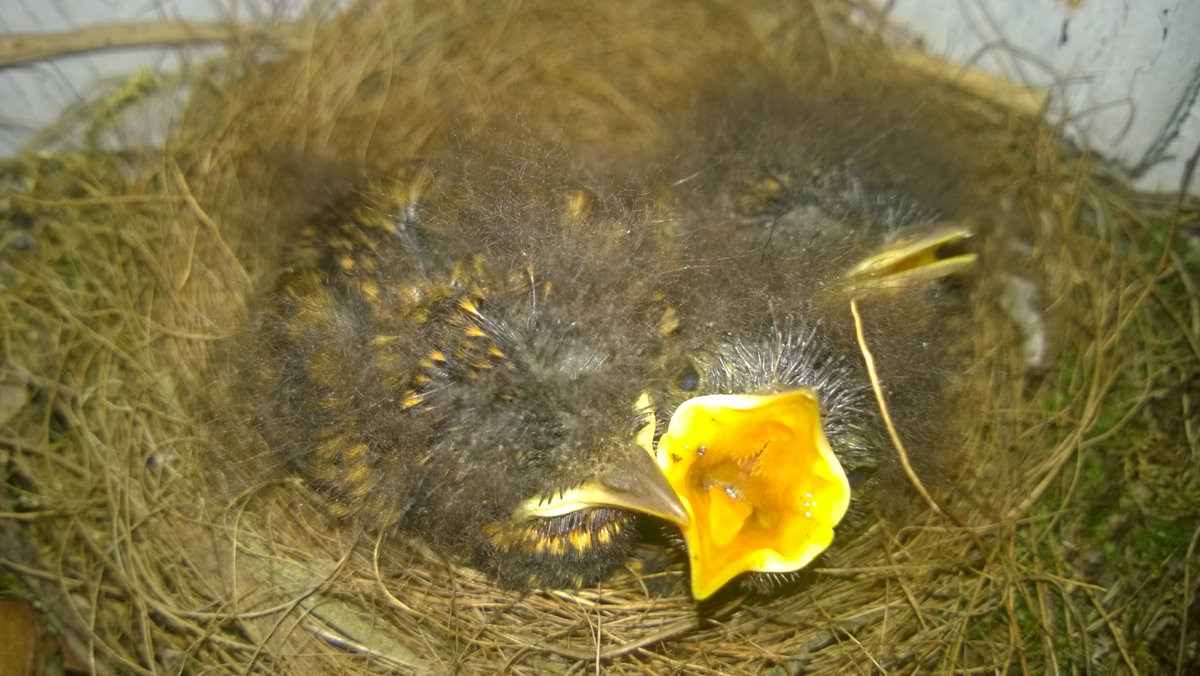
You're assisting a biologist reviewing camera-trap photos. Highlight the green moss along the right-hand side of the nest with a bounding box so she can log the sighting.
[1013,219,1200,671]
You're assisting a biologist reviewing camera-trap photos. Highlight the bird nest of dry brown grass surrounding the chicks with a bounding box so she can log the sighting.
[0,0,1200,674]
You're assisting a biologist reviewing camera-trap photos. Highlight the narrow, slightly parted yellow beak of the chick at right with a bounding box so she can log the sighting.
[845,223,978,297]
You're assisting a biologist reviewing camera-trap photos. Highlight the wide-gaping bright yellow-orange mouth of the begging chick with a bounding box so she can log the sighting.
[655,389,850,599]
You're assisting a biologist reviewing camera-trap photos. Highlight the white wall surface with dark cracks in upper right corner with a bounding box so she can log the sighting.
[875,0,1200,192]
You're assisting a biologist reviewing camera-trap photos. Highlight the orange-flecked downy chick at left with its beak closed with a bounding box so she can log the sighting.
[248,151,688,588]
